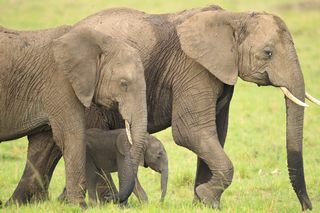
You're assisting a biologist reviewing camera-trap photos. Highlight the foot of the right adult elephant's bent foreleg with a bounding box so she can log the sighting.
[194,183,221,210]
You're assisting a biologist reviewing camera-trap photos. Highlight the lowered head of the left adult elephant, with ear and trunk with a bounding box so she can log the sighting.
[53,28,147,201]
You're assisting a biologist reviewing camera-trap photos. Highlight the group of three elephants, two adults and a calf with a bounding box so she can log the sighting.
[0,5,319,210]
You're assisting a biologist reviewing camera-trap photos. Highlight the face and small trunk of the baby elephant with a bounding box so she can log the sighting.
[144,135,168,202]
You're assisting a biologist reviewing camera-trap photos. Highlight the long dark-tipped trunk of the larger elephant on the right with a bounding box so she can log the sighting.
[285,68,312,210]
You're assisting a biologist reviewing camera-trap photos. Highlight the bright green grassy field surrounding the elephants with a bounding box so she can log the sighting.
[0,0,320,212]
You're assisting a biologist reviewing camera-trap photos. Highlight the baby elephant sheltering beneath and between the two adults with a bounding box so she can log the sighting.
[58,128,168,203]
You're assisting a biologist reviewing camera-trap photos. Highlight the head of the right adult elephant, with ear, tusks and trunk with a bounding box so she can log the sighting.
[177,10,319,210]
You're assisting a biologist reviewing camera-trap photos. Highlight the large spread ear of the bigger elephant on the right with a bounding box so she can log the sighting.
[177,11,238,85]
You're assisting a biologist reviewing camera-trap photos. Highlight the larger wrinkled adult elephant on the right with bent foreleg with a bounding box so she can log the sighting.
[11,6,312,210]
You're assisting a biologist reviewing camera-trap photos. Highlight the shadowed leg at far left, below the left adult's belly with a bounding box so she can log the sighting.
[6,131,62,205]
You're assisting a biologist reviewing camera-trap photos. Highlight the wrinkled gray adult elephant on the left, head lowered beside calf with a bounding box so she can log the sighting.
[0,26,147,207]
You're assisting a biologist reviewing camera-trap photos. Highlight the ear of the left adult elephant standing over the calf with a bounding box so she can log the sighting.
[53,28,112,107]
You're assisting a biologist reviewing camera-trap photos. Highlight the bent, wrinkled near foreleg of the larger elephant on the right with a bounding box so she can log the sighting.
[172,71,233,208]
